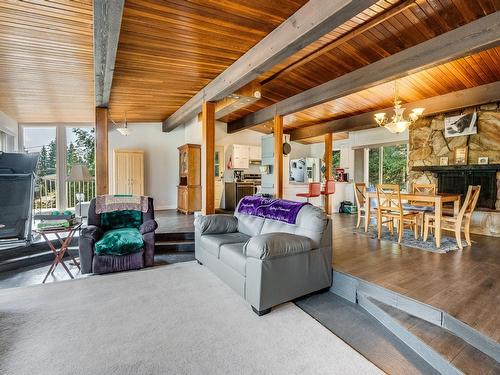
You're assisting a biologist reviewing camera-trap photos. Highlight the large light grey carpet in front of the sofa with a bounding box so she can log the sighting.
[0,262,382,375]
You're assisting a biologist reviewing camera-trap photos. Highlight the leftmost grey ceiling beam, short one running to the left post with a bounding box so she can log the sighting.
[94,0,125,107]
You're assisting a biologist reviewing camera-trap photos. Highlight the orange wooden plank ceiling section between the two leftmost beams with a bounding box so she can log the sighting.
[109,0,307,121]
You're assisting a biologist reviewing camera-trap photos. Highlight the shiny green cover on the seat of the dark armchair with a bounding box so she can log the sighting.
[94,228,144,255]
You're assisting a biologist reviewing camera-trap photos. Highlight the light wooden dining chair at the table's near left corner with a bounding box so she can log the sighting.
[377,184,418,243]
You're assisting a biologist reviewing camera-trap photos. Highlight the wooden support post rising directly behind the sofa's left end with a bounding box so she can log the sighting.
[201,102,215,215]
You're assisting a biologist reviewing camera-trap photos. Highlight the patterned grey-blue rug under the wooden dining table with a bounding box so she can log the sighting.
[352,227,468,253]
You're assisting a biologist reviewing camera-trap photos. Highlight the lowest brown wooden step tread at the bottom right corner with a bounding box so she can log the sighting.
[366,297,500,375]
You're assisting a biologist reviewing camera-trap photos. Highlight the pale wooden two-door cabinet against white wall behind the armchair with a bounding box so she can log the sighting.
[113,149,144,195]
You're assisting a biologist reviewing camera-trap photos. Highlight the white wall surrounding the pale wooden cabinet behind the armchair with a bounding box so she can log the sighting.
[108,123,185,209]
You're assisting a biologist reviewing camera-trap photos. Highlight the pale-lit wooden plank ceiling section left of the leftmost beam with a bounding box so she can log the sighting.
[0,0,94,123]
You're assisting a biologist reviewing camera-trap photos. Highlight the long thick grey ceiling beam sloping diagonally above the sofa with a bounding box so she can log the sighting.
[163,0,377,132]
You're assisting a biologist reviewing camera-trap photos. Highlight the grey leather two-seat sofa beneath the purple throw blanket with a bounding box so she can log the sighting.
[195,202,332,315]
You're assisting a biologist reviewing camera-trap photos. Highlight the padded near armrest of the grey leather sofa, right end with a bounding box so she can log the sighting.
[243,233,313,259]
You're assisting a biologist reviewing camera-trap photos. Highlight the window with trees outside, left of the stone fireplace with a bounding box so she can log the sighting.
[368,143,408,190]
